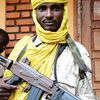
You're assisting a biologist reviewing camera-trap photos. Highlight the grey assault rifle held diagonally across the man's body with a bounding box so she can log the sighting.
[0,56,81,100]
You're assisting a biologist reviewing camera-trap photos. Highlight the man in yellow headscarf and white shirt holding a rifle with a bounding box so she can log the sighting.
[0,0,94,100]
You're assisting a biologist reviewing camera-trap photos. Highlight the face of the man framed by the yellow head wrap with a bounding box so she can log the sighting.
[36,3,64,31]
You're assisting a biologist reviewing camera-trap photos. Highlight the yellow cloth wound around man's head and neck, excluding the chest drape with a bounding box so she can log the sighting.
[31,0,68,43]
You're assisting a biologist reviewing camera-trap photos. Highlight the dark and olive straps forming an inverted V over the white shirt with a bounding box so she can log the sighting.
[54,34,91,82]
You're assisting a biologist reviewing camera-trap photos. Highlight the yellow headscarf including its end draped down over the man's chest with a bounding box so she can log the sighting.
[25,0,68,77]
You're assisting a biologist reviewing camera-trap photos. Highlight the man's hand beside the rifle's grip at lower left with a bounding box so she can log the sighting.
[0,78,18,100]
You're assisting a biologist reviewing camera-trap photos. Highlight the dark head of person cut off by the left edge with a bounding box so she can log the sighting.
[0,29,9,53]
